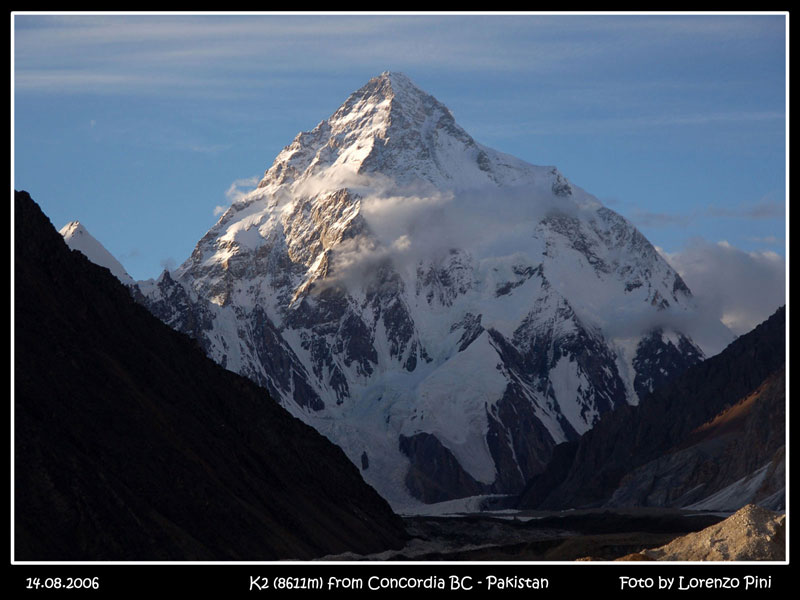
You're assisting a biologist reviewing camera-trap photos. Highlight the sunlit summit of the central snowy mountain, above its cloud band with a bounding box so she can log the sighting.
[259,71,571,196]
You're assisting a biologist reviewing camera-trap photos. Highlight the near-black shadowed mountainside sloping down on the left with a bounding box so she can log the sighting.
[14,192,406,561]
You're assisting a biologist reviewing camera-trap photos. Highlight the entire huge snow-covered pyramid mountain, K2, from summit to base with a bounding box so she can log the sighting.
[134,73,728,507]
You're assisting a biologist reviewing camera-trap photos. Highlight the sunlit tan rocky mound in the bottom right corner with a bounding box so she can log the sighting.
[630,504,786,561]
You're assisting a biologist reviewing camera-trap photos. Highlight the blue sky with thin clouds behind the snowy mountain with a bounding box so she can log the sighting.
[12,13,788,332]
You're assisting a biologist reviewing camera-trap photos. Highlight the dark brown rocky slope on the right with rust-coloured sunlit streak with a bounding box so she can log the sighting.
[520,308,786,509]
